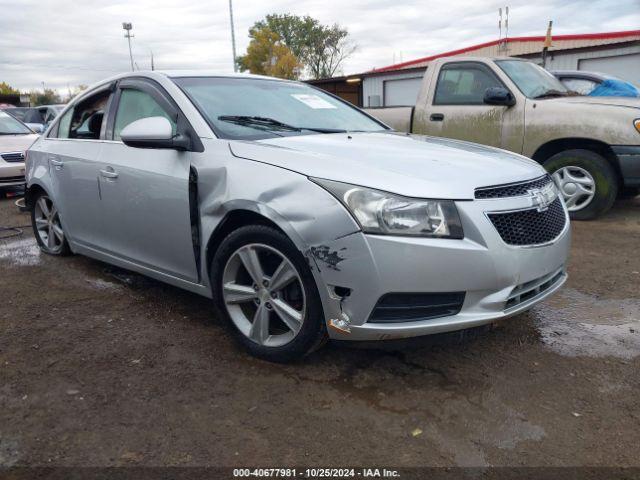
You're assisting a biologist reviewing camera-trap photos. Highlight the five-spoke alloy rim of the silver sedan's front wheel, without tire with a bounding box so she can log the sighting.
[222,243,306,347]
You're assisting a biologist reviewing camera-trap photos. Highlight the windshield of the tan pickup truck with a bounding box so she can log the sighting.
[496,60,569,98]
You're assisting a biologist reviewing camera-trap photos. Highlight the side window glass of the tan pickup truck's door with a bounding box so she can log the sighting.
[433,65,502,105]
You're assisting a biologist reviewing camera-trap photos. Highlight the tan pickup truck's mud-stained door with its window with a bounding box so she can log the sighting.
[418,61,522,148]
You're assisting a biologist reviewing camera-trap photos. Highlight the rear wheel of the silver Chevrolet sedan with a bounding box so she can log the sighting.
[31,192,71,256]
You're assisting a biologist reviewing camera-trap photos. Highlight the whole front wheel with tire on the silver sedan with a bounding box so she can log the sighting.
[211,225,327,362]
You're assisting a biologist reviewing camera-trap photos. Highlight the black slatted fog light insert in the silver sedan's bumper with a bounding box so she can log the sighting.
[369,292,465,323]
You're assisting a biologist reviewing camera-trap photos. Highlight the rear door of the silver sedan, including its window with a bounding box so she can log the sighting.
[45,87,111,247]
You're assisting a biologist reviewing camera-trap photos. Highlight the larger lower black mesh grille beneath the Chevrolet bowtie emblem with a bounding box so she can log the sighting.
[487,198,567,246]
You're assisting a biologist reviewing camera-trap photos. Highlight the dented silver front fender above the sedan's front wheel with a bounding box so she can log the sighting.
[192,139,360,318]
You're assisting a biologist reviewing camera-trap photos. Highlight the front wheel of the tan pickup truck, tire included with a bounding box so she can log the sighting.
[544,149,618,220]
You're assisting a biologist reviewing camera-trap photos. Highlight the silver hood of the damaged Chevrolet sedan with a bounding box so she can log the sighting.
[229,133,544,200]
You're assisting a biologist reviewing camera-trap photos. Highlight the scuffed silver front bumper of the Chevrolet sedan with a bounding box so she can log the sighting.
[310,193,570,340]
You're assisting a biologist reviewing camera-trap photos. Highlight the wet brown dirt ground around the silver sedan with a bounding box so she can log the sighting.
[0,198,640,467]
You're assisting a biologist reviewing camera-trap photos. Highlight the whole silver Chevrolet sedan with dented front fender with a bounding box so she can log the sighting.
[27,72,570,361]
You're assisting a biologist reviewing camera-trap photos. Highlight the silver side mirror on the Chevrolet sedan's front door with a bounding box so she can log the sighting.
[120,117,191,150]
